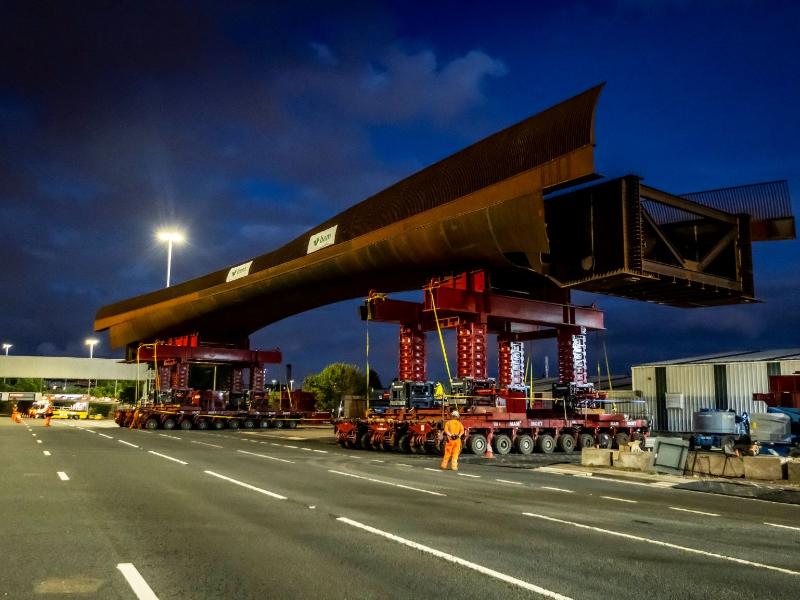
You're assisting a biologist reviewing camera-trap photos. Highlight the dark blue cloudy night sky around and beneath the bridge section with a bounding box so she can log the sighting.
[0,0,800,381]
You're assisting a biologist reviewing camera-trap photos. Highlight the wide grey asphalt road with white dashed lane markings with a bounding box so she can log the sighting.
[0,418,800,600]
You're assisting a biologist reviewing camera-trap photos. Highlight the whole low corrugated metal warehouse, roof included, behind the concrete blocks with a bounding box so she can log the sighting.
[631,348,800,431]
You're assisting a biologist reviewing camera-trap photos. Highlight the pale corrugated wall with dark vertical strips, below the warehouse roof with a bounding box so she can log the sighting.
[631,360,800,431]
